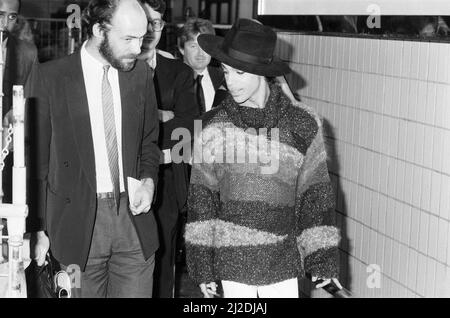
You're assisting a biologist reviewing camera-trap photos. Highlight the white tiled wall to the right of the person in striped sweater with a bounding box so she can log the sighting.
[278,32,450,297]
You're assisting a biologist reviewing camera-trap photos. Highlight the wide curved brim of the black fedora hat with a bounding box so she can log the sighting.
[198,34,291,77]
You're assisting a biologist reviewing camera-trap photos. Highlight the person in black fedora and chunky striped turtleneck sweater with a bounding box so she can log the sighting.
[185,19,340,298]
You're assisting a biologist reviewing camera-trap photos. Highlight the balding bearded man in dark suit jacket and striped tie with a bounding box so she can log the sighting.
[26,0,161,297]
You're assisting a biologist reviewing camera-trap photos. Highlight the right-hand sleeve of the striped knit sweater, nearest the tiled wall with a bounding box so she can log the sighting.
[295,118,340,279]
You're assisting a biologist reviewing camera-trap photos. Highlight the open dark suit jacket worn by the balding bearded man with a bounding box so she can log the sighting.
[26,52,160,270]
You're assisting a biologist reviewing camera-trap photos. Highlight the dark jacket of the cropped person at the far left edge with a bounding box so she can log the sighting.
[3,35,38,116]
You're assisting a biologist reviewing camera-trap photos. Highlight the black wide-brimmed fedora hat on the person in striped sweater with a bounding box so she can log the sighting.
[198,19,291,77]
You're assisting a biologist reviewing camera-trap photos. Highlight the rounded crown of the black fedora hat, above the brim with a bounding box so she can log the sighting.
[222,19,277,63]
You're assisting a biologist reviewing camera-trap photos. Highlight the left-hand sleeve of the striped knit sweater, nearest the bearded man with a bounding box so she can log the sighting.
[185,128,220,283]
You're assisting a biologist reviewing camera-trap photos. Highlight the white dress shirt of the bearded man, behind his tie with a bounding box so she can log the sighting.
[81,42,125,193]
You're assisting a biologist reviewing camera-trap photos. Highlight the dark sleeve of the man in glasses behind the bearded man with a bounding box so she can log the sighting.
[163,67,199,148]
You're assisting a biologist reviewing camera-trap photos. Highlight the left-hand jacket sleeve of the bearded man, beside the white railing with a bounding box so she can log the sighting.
[25,64,52,231]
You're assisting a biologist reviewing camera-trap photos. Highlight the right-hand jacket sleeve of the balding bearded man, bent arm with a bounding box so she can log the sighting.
[139,67,161,186]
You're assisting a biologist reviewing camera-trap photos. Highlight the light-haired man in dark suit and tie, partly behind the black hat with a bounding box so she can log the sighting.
[178,18,227,115]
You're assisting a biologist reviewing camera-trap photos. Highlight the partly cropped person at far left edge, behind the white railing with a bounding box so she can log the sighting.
[0,0,37,203]
